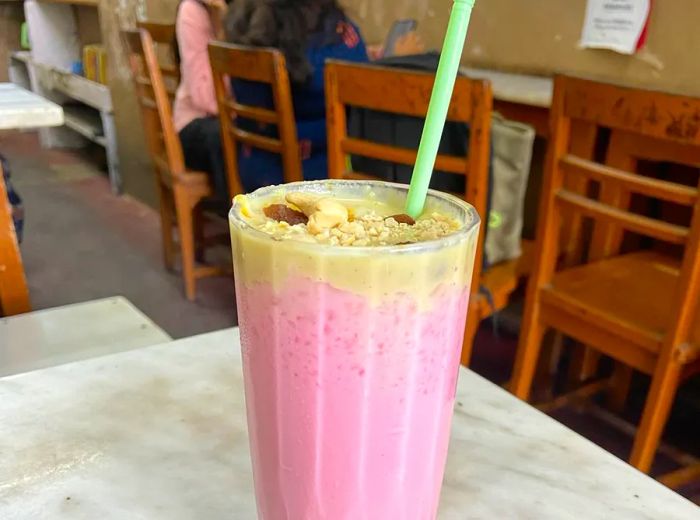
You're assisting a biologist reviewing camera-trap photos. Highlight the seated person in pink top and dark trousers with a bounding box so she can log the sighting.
[173,0,230,203]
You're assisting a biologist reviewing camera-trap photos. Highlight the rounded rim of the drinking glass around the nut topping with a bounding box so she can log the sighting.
[228,179,481,255]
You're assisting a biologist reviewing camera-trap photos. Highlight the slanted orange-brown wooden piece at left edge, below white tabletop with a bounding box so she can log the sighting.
[0,165,32,316]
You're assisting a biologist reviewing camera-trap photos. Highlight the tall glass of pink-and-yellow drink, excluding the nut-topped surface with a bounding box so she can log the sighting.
[231,181,479,520]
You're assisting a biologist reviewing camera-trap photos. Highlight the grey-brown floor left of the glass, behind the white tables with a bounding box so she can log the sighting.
[0,133,236,338]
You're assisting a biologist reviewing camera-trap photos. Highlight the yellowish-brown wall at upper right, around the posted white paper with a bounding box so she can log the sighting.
[342,0,700,96]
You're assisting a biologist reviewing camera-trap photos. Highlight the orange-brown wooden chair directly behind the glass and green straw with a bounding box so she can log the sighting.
[325,61,524,365]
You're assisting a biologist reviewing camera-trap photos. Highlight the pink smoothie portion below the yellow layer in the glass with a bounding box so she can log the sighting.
[236,273,468,520]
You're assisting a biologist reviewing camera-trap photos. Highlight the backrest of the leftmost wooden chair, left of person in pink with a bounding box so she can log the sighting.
[122,29,185,185]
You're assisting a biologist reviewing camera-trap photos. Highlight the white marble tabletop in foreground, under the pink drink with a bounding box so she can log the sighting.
[0,329,700,520]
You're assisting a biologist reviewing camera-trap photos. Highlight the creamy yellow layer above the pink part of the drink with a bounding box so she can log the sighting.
[231,220,477,304]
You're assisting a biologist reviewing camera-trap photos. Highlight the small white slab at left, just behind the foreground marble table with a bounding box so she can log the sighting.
[0,296,172,378]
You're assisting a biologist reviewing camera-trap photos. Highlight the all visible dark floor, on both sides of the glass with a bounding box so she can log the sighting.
[0,133,700,501]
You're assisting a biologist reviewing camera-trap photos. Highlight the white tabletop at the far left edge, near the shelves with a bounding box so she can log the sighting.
[0,83,63,130]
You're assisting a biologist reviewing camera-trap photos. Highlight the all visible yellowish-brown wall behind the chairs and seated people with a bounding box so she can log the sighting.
[104,0,700,203]
